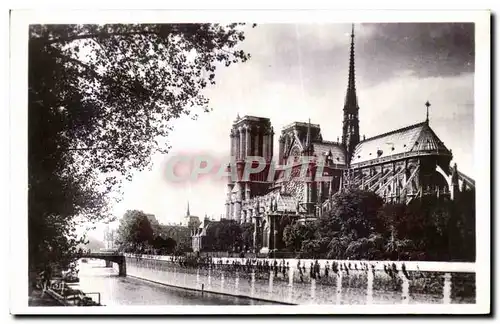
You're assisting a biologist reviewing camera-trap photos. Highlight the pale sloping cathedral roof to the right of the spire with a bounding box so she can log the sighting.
[351,122,451,164]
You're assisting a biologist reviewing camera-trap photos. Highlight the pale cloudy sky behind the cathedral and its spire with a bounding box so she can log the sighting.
[91,23,474,237]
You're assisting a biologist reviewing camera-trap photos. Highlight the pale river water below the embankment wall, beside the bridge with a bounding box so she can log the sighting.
[74,260,280,306]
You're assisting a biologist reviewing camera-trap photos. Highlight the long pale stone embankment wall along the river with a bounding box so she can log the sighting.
[122,255,475,304]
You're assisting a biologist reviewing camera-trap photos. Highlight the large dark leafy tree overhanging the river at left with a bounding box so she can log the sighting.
[28,24,254,269]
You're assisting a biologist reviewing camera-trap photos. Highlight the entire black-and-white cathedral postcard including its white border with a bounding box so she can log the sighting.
[10,10,490,314]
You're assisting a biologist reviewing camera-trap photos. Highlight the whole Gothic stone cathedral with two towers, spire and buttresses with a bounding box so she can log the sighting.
[225,28,475,253]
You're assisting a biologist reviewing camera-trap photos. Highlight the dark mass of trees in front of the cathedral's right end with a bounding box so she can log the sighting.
[283,190,475,261]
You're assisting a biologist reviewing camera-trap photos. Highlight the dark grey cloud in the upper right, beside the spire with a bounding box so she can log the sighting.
[357,23,475,84]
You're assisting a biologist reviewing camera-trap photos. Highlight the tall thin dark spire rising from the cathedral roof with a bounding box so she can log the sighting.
[342,24,359,164]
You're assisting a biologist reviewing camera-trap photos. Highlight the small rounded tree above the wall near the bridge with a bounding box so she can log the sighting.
[118,210,153,250]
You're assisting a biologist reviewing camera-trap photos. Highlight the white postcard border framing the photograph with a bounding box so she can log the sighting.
[8,10,491,314]
